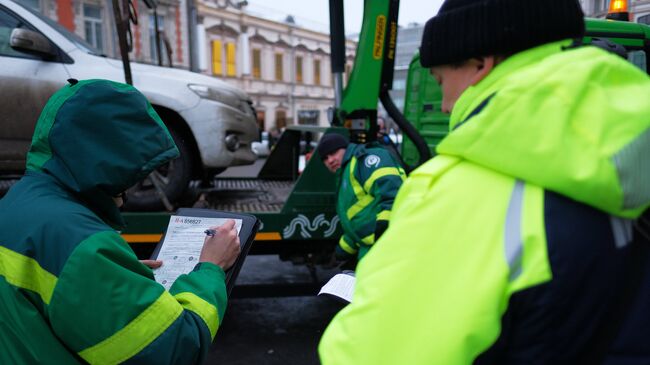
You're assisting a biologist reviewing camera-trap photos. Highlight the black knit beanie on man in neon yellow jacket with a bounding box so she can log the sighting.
[420,0,585,67]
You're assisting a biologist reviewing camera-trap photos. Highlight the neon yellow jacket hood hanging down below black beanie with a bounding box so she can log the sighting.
[438,41,650,218]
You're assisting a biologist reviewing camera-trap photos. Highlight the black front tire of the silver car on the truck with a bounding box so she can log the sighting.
[124,128,192,211]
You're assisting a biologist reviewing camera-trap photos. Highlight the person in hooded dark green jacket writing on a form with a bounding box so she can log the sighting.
[0,79,239,364]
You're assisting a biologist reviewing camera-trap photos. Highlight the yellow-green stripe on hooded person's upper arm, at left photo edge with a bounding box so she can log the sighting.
[0,247,58,304]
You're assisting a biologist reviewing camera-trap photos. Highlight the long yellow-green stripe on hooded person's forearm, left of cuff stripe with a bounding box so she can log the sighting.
[79,291,183,364]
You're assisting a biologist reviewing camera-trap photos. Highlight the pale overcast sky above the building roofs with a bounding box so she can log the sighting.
[246,0,442,34]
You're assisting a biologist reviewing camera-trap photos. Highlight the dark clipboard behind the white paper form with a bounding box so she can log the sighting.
[151,208,260,296]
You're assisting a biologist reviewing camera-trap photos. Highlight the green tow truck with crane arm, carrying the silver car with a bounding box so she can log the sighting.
[122,0,650,284]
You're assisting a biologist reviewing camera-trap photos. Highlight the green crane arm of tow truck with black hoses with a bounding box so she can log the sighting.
[330,0,431,168]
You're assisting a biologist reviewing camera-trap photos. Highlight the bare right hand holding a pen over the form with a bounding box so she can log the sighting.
[199,219,241,271]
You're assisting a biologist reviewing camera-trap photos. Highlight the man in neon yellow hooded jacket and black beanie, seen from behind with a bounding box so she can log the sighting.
[319,0,650,365]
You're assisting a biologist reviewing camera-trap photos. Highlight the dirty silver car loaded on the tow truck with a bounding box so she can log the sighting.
[0,0,258,210]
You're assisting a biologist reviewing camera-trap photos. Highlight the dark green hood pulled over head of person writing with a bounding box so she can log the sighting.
[27,80,179,226]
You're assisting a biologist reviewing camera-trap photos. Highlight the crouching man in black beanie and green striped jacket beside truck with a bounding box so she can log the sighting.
[316,133,406,260]
